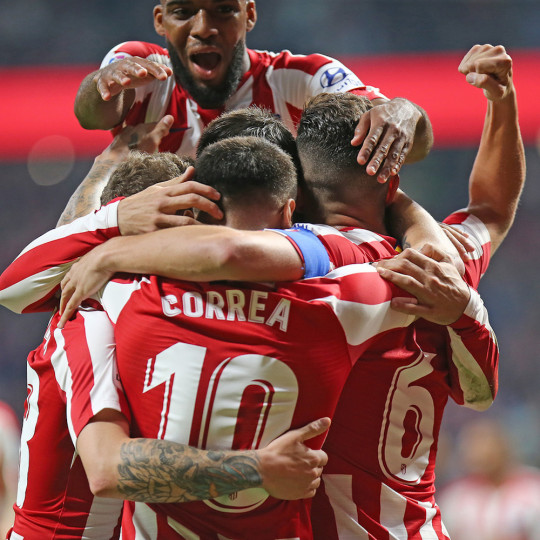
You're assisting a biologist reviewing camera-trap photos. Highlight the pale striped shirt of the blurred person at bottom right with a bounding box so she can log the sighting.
[439,467,540,540]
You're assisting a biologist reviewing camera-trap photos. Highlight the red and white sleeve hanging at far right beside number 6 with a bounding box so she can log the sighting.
[447,289,499,410]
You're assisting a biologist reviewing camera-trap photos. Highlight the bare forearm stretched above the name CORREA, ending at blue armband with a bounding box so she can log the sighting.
[97,225,303,281]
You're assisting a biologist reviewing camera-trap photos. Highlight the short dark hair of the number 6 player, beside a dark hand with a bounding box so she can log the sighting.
[296,93,373,179]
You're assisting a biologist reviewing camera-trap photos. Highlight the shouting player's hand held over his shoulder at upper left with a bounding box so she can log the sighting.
[94,56,172,101]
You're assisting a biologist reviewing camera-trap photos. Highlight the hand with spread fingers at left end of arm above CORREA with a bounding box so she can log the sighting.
[58,246,115,328]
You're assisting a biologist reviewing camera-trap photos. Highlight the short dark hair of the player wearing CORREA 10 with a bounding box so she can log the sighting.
[194,136,297,212]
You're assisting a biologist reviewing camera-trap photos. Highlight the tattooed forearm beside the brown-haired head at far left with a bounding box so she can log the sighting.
[56,159,123,227]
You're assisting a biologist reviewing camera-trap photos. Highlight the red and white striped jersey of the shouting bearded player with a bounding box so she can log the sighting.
[101,41,384,155]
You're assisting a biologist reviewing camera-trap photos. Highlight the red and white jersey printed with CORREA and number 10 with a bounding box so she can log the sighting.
[96,265,496,540]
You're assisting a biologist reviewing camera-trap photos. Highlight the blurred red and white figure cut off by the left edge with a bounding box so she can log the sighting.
[0,401,21,538]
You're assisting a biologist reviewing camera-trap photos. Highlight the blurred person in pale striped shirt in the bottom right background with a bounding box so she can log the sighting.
[439,419,540,540]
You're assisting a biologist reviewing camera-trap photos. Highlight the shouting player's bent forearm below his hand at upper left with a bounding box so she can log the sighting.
[74,70,135,129]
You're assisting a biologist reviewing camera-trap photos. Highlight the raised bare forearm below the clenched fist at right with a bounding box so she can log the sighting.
[468,87,526,252]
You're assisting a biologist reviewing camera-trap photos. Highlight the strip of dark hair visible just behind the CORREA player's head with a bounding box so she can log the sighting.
[197,105,301,172]
